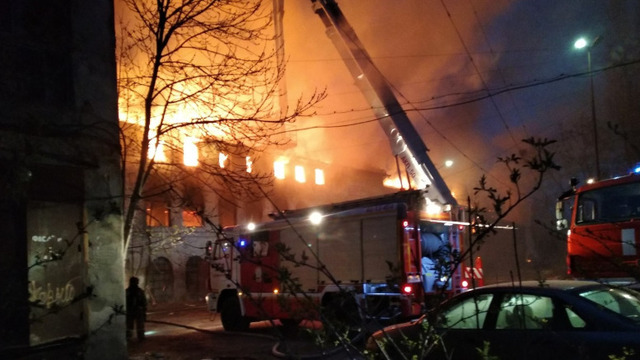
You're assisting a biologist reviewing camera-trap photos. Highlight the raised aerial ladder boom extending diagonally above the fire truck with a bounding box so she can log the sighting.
[311,0,457,206]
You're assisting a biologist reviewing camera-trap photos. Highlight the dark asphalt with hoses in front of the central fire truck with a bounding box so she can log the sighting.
[128,305,362,360]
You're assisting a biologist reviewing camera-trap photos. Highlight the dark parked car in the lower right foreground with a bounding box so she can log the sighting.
[367,280,640,360]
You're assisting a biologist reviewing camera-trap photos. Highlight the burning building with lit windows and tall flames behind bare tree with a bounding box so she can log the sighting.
[116,1,392,303]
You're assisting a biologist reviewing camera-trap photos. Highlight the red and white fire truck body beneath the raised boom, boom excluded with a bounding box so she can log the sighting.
[208,190,464,330]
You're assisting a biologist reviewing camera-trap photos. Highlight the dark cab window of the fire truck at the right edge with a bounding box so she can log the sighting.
[576,183,640,224]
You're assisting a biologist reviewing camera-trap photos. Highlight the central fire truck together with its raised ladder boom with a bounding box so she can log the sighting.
[207,0,468,330]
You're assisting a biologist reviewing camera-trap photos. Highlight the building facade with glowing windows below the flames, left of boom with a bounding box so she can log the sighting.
[120,132,393,306]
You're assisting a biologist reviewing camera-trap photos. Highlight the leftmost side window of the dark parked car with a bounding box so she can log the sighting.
[441,294,493,329]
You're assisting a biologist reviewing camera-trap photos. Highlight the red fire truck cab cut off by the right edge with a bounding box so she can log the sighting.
[556,167,640,283]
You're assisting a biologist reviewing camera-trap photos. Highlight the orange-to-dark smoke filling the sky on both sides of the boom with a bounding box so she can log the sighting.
[285,0,640,278]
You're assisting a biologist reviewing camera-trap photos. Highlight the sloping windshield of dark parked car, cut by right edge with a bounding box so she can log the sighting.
[579,287,640,323]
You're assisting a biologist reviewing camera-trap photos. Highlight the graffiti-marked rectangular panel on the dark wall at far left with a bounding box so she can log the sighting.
[27,201,87,345]
